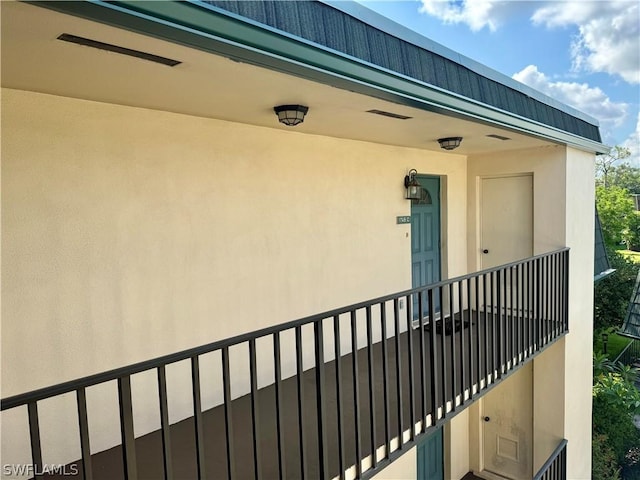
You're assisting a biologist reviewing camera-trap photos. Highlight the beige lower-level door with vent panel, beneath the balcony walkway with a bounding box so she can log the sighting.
[480,362,533,480]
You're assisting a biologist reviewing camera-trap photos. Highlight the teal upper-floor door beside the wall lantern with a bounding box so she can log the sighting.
[411,176,440,317]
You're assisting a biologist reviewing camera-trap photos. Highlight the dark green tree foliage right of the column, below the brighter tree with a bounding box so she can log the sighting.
[593,248,638,332]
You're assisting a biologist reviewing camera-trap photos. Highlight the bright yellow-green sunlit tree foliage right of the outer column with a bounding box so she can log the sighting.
[596,186,636,248]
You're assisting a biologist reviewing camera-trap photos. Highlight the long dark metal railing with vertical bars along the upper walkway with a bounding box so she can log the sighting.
[2,249,569,479]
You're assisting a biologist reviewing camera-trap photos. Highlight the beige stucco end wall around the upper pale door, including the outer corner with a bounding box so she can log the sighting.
[467,146,594,480]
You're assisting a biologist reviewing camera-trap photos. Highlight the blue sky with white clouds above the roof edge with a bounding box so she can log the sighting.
[359,0,640,167]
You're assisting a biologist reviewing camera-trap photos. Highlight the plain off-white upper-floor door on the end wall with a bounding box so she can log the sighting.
[480,174,533,269]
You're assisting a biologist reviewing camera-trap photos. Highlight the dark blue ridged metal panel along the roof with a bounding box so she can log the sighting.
[206,0,601,142]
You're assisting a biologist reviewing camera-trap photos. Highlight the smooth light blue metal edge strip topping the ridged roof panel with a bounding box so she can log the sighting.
[324,0,600,127]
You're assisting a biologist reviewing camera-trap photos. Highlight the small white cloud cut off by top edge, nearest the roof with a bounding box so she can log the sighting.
[420,0,515,32]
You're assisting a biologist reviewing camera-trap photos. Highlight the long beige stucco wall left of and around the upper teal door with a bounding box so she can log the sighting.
[2,89,467,462]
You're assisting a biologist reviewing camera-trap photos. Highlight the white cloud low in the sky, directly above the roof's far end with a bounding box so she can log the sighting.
[513,65,629,136]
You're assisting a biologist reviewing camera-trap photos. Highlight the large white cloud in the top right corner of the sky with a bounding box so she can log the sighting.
[531,0,640,83]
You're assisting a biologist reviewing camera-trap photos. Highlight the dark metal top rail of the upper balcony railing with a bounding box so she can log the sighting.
[0,247,569,410]
